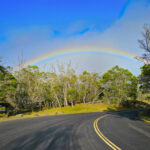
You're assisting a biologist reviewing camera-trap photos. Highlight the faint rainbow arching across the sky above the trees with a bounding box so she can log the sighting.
[25,46,138,66]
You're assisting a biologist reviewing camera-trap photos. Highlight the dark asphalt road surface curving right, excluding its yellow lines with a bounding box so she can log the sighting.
[0,111,150,150]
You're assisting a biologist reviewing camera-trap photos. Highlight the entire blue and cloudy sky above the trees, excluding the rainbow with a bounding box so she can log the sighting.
[0,0,150,75]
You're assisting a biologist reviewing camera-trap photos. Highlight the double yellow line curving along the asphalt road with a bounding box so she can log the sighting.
[93,115,121,150]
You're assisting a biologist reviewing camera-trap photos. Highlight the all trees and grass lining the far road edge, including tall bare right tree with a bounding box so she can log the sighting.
[0,25,150,120]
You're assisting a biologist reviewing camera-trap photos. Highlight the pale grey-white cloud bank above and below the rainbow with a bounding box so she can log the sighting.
[0,0,150,74]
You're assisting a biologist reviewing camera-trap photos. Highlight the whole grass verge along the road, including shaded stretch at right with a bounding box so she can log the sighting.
[0,101,150,121]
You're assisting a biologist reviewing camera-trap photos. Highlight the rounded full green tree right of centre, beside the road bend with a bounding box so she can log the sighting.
[101,66,137,103]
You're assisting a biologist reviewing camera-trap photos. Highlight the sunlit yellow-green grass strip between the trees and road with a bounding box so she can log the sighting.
[0,103,110,121]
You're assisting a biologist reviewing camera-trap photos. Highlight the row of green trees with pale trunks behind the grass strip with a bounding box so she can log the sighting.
[0,64,138,112]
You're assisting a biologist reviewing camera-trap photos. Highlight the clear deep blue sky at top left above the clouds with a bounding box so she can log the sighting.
[0,0,128,39]
